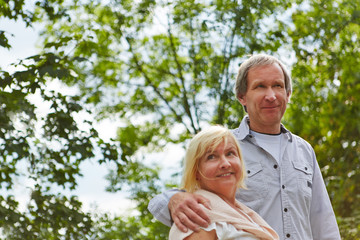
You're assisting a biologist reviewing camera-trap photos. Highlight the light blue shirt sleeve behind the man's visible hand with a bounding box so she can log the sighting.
[148,189,180,227]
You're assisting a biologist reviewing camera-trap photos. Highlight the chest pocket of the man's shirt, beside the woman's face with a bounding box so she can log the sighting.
[237,163,269,203]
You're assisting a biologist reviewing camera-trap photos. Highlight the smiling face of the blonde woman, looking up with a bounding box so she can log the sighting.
[196,139,241,200]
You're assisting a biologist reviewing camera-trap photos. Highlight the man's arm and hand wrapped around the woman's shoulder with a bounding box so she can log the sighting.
[148,190,211,232]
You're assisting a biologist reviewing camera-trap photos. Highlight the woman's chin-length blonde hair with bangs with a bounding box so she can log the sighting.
[182,125,246,192]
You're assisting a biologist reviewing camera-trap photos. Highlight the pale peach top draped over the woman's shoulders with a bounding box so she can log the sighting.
[169,189,279,240]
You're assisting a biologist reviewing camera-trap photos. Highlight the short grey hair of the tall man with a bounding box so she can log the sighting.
[234,54,292,99]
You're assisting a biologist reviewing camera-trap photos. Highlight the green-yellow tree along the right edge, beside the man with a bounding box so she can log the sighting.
[289,0,360,236]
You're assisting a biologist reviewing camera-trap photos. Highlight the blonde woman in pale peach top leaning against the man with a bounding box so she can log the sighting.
[169,126,279,240]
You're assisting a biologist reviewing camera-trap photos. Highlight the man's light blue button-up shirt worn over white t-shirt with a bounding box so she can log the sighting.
[148,116,341,240]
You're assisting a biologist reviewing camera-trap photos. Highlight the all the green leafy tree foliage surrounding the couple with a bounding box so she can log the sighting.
[0,0,360,239]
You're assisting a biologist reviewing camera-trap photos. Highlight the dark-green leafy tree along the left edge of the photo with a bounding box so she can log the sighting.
[0,1,117,239]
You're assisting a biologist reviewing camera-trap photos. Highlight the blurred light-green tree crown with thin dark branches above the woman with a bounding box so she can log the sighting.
[40,1,288,135]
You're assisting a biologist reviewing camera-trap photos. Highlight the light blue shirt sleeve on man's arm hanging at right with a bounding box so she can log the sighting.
[310,153,341,240]
